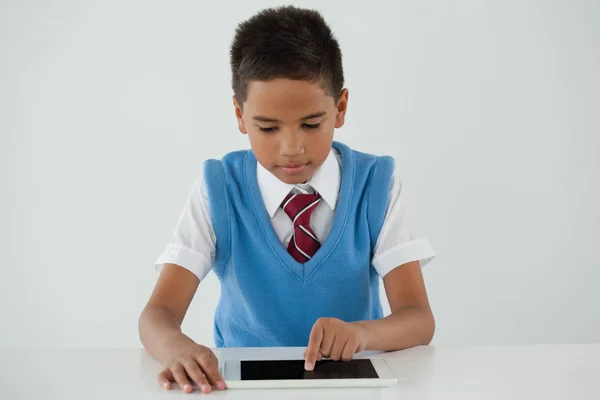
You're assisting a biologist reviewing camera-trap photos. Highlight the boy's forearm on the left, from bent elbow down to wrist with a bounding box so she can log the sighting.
[138,307,185,363]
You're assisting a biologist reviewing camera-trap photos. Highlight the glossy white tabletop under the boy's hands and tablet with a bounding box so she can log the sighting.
[0,344,600,400]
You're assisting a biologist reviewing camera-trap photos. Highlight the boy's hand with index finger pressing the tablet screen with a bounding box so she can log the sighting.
[304,318,368,371]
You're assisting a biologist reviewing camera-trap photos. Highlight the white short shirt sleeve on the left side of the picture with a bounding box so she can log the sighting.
[155,171,216,280]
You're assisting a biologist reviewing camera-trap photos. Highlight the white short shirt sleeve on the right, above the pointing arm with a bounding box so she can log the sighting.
[373,174,435,277]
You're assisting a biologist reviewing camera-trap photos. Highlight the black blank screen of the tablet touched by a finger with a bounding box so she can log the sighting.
[241,359,379,381]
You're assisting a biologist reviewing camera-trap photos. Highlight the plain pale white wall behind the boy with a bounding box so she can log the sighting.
[0,0,600,347]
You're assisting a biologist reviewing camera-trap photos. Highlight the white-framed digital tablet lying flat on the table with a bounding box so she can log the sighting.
[223,358,396,389]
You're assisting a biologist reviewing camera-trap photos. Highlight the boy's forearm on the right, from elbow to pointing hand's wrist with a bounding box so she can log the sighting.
[356,307,435,351]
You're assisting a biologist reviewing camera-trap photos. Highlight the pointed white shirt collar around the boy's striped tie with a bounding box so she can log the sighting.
[256,149,341,218]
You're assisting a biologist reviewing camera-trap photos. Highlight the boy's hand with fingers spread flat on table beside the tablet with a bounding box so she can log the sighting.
[158,335,225,393]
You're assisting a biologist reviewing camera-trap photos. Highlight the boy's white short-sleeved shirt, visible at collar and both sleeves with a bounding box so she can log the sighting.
[156,149,435,280]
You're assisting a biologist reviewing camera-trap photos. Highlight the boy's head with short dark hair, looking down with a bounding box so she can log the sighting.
[231,6,348,183]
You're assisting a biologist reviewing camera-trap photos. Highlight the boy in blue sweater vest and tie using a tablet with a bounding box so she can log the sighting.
[139,7,434,393]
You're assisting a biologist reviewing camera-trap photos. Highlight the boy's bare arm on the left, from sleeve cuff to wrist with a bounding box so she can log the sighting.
[138,264,200,364]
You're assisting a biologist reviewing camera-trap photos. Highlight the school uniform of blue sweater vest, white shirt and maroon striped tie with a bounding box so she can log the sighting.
[156,142,435,347]
